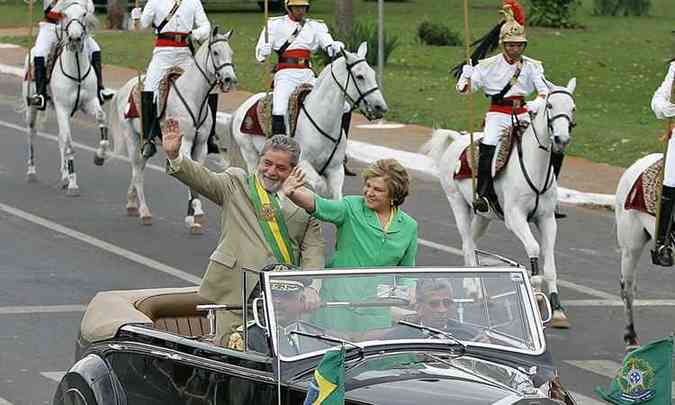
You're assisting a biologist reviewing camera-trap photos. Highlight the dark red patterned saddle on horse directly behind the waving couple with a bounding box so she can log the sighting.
[239,84,313,138]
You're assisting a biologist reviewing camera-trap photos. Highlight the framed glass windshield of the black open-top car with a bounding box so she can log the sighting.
[265,268,544,358]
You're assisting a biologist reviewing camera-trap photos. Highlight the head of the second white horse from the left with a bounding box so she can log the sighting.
[202,27,238,93]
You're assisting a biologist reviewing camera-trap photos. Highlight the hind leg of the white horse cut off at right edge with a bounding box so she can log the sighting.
[616,211,649,351]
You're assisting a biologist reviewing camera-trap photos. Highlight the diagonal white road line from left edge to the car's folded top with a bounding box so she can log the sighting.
[0,203,201,284]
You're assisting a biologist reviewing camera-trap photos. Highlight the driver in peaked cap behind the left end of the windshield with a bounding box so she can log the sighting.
[227,280,325,355]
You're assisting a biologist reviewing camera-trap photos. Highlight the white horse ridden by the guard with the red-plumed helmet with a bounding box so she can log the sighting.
[422,79,576,328]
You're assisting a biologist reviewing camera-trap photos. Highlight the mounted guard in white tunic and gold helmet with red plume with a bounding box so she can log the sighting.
[456,0,563,217]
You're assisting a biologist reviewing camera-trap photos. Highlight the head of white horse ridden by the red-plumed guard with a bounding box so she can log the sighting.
[545,78,577,153]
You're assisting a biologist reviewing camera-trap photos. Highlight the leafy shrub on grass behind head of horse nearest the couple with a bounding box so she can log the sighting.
[319,22,399,67]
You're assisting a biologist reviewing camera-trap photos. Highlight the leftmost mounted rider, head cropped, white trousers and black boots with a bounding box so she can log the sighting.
[29,0,105,110]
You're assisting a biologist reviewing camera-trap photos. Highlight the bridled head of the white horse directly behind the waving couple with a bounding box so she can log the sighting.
[333,42,389,120]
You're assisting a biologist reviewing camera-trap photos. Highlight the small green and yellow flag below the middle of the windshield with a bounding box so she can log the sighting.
[304,347,345,405]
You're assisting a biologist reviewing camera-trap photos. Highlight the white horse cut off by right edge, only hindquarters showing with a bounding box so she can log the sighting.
[614,153,663,350]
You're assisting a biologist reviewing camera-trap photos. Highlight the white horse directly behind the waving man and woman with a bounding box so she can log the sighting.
[228,42,388,198]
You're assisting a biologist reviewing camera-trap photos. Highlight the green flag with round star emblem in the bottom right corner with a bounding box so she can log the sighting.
[595,336,673,405]
